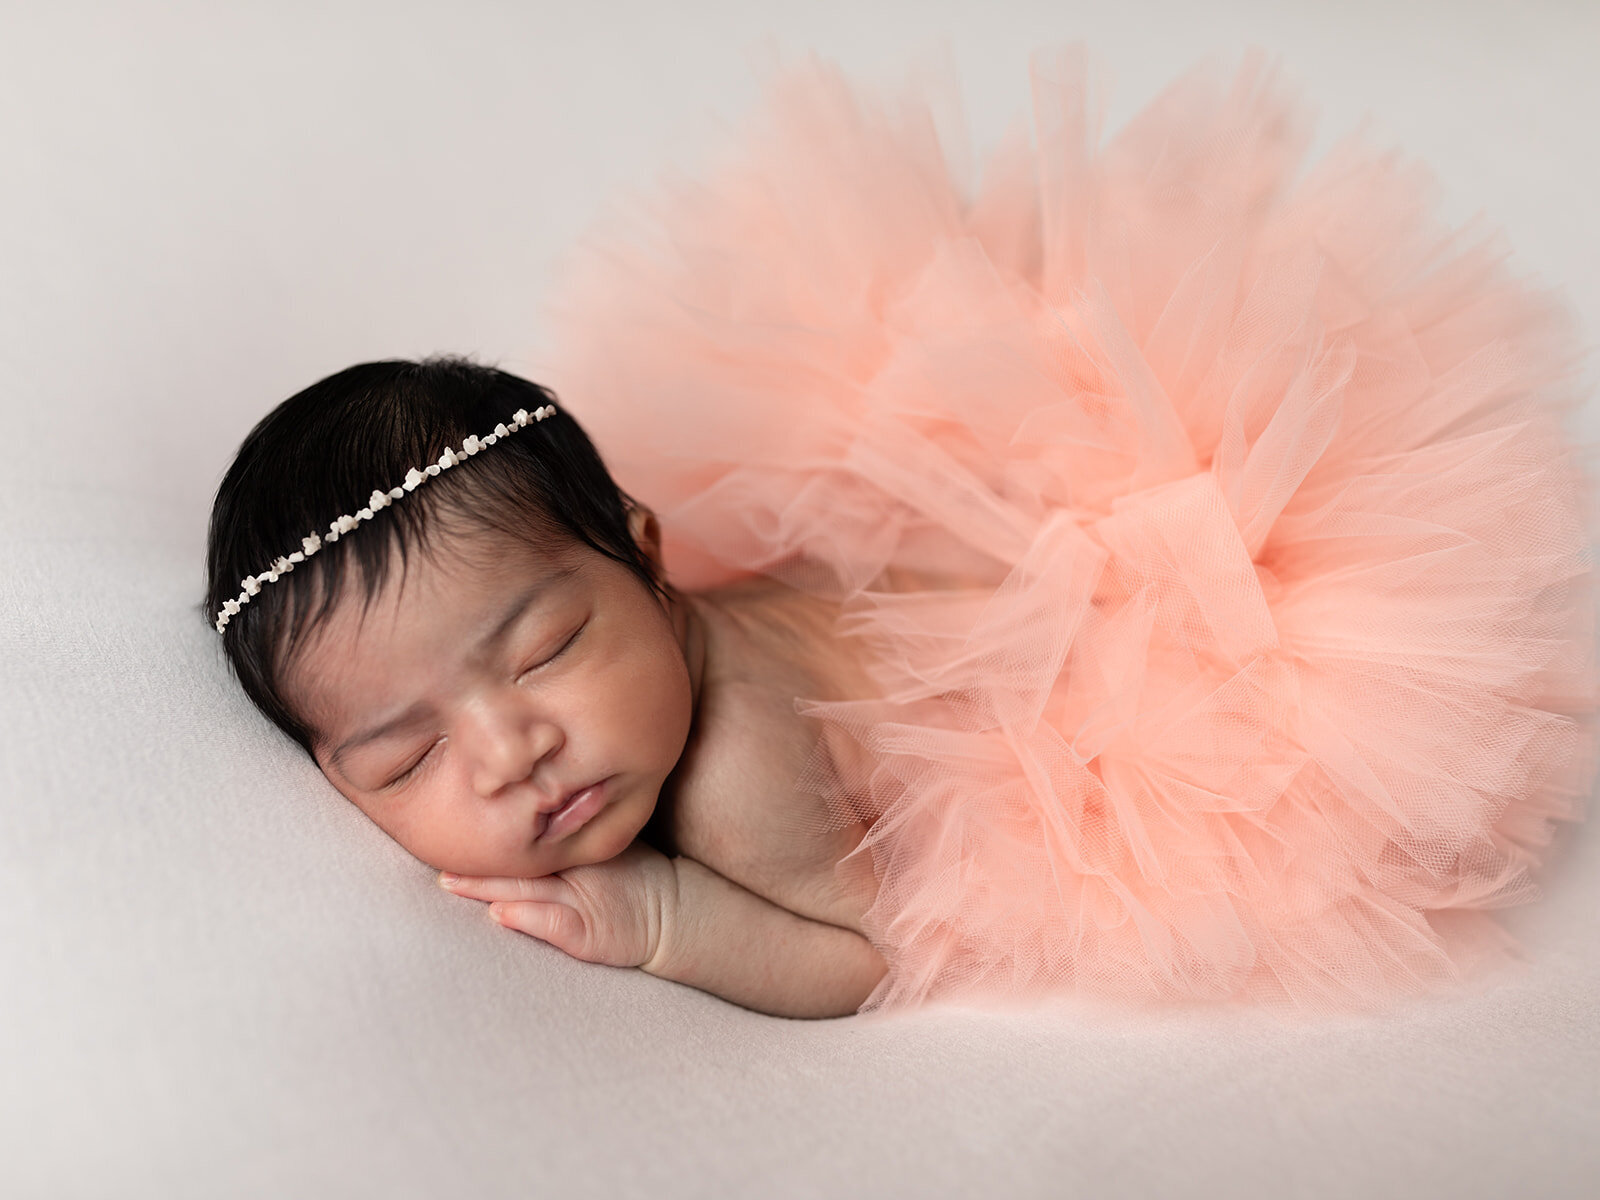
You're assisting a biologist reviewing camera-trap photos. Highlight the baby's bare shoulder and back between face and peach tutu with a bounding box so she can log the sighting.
[646,579,872,933]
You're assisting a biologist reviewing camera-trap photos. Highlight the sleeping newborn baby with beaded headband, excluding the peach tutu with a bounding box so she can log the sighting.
[206,357,886,1018]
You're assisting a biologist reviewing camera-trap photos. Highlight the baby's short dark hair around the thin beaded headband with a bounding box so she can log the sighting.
[203,355,672,754]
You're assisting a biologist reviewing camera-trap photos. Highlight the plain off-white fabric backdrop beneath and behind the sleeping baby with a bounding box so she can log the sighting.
[0,0,1600,1200]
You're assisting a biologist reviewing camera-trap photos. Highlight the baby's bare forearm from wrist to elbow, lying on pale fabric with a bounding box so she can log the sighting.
[642,858,888,1018]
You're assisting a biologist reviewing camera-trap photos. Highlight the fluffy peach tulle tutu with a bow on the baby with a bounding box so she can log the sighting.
[539,46,1600,1013]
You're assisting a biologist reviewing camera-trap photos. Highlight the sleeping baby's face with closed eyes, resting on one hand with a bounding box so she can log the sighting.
[285,522,694,877]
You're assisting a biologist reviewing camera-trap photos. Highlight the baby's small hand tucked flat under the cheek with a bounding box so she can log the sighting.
[440,840,678,966]
